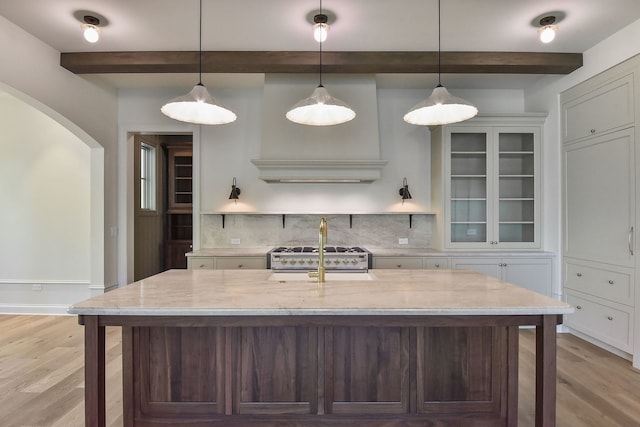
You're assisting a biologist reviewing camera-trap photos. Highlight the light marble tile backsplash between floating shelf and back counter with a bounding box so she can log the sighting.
[200,214,433,249]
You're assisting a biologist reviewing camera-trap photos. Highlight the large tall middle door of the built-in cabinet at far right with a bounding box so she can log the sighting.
[564,129,635,267]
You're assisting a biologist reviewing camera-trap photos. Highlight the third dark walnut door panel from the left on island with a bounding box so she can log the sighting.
[324,326,410,415]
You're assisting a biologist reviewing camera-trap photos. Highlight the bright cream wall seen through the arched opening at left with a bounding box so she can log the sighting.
[0,94,91,312]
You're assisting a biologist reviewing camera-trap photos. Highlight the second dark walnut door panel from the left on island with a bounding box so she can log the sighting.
[232,326,318,415]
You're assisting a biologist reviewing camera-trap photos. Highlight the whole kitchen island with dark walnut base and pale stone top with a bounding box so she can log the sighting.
[69,270,572,427]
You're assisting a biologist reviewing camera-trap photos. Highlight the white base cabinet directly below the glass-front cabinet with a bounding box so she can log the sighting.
[451,257,553,296]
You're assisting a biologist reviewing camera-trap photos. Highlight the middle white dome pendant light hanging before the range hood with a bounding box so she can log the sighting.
[287,0,356,126]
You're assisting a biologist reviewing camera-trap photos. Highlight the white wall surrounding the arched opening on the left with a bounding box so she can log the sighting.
[0,17,117,311]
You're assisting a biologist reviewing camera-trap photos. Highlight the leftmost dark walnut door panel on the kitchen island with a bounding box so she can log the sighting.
[123,327,225,425]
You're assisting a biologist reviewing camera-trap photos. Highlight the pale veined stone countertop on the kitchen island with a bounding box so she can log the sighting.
[68,270,573,316]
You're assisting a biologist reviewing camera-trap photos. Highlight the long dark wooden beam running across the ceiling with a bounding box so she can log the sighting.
[60,51,582,74]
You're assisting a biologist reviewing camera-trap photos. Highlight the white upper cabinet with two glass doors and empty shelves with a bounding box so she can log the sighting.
[432,117,541,249]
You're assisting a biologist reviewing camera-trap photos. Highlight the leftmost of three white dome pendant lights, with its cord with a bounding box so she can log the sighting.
[160,0,237,125]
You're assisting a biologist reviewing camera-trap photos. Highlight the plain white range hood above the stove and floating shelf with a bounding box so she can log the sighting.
[251,74,387,183]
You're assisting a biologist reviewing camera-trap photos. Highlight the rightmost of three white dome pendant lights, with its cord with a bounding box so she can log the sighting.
[404,0,478,126]
